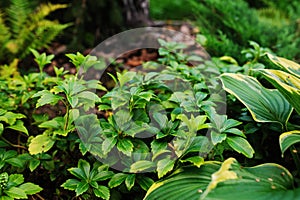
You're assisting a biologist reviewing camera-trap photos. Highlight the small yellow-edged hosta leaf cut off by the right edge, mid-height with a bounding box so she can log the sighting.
[279,130,300,156]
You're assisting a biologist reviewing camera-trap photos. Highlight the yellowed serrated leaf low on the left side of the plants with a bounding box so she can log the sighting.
[28,134,55,155]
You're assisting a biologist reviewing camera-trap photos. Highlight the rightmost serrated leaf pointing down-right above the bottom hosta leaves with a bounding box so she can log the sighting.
[226,136,254,158]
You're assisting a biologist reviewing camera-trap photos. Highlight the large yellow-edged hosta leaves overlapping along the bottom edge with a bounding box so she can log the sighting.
[144,158,300,200]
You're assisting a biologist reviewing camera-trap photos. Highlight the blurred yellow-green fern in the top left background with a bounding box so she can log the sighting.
[0,0,69,64]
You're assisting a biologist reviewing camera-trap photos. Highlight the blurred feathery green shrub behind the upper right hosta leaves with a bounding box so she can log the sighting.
[190,0,300,62]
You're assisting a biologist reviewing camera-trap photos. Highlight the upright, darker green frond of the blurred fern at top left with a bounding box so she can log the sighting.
[7,0,33,38]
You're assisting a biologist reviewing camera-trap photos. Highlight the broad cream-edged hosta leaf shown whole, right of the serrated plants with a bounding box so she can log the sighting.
[221,73,292,125]
